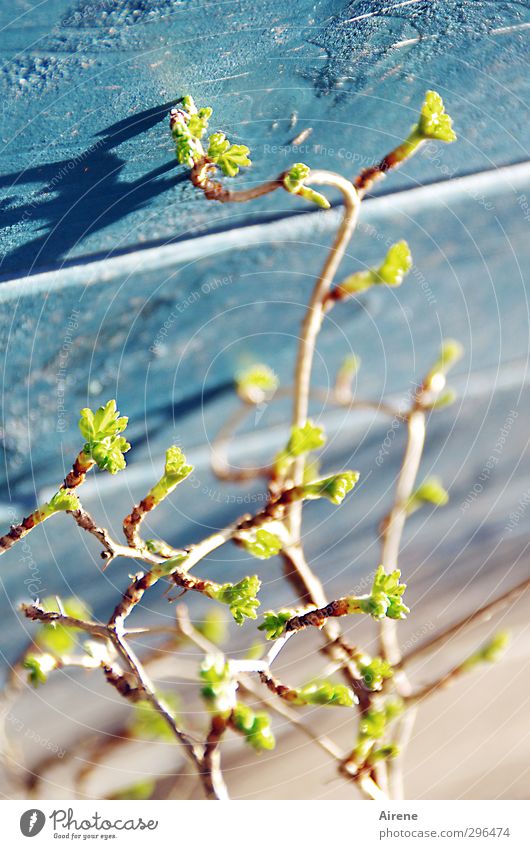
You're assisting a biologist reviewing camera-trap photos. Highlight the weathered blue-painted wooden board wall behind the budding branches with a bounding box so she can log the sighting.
[0,0,530,656]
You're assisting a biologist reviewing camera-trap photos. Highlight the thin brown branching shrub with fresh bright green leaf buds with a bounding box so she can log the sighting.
[0,91,512,799]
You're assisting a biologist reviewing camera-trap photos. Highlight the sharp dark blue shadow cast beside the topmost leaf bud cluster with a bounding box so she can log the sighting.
[0,102,186,276]
